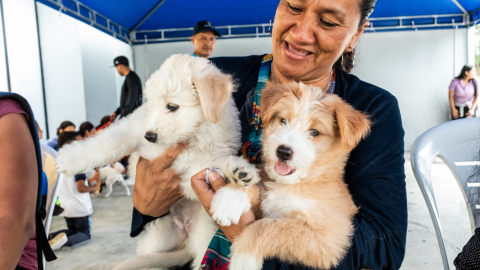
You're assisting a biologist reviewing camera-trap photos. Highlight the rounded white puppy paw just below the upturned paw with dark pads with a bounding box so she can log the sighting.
[210,187,251,226]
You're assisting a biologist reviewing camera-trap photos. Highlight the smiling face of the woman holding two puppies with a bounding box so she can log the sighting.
[272,0,369,81]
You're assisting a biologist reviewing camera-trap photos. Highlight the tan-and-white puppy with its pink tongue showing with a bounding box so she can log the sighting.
[229,83,370,270]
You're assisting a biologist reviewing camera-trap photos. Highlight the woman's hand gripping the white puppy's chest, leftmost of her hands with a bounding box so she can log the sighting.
[133,144,186,217]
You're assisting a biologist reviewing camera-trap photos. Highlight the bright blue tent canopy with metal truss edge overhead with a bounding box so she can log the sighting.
[37,0,480,42]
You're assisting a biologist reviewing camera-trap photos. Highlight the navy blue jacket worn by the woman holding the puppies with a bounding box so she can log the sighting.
[132,56,407,270]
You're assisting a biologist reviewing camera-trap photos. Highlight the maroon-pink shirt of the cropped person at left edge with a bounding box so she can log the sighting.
[0,99,38,270]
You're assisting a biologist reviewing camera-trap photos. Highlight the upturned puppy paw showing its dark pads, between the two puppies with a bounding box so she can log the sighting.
[221,156,260,187]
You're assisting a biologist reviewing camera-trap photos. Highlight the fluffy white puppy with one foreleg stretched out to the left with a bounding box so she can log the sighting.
[56,55,259,269]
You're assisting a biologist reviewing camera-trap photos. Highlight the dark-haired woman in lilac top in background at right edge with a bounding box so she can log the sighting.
[448,65,478,119]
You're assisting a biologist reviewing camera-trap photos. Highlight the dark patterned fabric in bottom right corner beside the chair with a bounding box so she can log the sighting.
[453,228,480,270]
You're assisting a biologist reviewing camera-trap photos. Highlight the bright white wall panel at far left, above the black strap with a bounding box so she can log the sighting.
[0,0,46,136]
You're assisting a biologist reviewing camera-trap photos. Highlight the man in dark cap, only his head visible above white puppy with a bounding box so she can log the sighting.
[192,21,220,58]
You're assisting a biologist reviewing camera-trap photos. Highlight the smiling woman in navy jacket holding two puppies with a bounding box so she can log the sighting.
[131,0,407,269]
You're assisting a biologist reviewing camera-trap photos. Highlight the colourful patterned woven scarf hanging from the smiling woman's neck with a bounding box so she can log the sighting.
[200,57,336,270]
